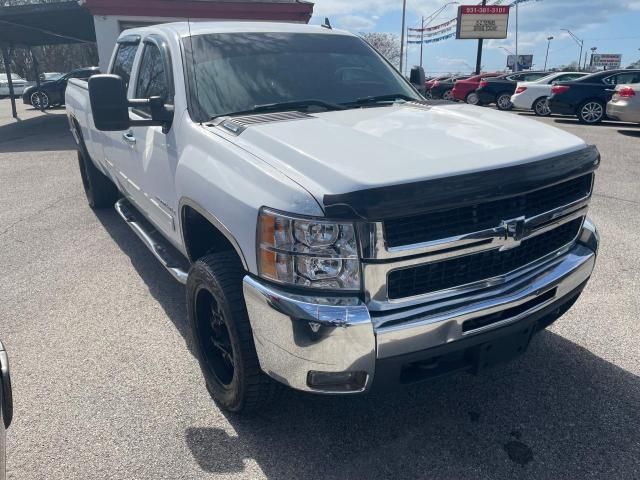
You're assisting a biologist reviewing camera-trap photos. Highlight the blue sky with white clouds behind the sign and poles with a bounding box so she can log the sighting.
[311,0,640,73]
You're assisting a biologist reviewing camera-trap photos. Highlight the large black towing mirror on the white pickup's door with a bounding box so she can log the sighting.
[89,75,131,132]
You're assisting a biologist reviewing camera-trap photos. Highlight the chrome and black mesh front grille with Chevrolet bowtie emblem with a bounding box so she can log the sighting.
[359,173,593,311]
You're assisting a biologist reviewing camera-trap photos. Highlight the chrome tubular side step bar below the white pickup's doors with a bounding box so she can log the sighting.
[115,198,189,284]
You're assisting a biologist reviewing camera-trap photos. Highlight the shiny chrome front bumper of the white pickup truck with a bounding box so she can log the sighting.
[244,221,598,393]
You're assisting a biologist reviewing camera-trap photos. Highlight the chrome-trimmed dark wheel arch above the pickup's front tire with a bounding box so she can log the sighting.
[178,197,249,271]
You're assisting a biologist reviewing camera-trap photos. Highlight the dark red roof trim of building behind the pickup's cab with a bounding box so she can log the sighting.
[86,0,313,22]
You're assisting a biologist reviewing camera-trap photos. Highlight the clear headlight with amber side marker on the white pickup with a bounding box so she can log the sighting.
[258,208,360,290]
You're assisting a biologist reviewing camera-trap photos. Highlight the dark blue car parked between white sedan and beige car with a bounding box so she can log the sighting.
[549,70,640,125]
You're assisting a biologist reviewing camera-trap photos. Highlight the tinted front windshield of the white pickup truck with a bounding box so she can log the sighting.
[184,32,420,119]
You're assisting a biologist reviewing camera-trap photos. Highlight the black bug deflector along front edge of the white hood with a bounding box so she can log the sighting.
[323,145,600,221]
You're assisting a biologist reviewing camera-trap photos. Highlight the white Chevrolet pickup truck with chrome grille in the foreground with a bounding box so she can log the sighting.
[66,22,600,411]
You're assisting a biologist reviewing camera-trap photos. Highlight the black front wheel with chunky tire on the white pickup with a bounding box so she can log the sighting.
[186,252,280,413]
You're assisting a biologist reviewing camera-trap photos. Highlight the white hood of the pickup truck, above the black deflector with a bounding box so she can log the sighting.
[232,104,585,202]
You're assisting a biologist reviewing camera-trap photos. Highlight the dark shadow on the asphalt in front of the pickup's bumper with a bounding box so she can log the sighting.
[185,332,640,479]
